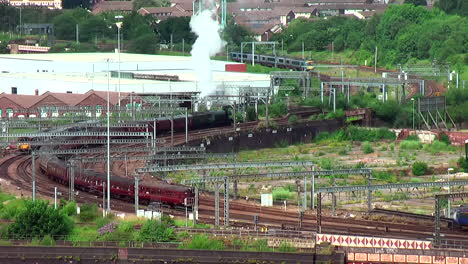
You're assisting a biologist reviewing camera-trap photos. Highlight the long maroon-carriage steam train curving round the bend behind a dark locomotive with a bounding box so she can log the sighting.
[34,111,232,207]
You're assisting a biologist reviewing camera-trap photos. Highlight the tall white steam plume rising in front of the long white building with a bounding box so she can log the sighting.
[190,0,224,97]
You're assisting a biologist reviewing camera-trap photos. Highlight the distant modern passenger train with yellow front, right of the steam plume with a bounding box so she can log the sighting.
[229,52,315,71]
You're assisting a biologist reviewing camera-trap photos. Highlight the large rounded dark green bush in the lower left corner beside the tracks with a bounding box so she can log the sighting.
[8,200,73,237]
